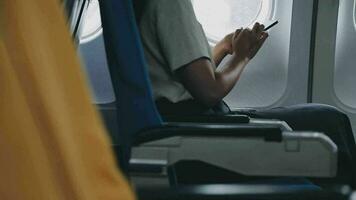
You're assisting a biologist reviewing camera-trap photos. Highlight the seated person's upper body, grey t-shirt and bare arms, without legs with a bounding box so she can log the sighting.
[136,0,268,114]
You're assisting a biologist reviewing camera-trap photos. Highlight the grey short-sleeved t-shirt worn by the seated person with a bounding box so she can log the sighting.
[139,0,212,103]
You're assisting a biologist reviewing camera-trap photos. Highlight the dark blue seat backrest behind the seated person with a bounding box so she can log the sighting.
[99,0,162,166]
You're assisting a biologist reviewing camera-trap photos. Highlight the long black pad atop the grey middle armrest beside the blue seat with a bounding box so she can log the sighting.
[133,123,282,145]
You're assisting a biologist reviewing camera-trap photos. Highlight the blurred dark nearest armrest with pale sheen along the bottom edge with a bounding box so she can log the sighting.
[137,184,351,200]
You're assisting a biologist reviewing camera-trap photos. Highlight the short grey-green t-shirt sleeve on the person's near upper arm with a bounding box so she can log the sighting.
[156,0,211,72]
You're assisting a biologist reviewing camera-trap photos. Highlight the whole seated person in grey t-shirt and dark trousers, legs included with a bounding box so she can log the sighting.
[134,0,356,186]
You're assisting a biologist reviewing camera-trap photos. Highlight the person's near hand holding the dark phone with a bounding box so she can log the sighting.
[232,23,268,60]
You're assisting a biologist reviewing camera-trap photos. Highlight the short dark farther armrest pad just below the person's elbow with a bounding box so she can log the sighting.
[163,114,250,124]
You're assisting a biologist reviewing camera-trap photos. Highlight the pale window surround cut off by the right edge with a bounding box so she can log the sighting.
[334,0,356,110]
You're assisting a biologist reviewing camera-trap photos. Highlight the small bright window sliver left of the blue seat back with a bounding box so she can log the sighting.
[80,0,102,43]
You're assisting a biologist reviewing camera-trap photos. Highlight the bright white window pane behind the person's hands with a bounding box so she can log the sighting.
[192,0,273,43]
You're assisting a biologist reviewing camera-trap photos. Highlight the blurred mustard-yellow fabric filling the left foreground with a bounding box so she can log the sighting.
[0,0,135,200]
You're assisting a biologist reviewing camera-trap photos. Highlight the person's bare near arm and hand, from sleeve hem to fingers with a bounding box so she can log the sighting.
[176,23,268,107]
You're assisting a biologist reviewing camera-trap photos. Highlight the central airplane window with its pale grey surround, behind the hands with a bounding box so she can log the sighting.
[191,0,294,109]
